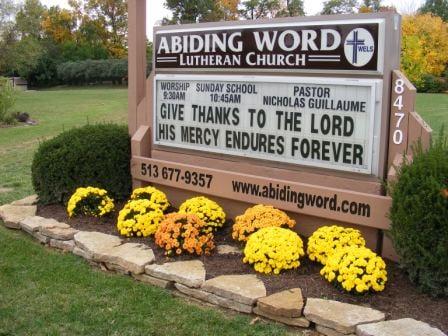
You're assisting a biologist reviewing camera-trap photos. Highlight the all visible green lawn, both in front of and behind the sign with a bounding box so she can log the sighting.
[0,88,448,335]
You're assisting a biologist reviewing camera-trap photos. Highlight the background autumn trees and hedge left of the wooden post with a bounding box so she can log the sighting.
[0,0,127,86]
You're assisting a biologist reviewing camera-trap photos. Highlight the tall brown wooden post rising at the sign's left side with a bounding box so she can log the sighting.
[128,0,146,135]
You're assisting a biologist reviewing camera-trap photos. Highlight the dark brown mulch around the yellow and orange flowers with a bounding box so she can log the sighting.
[37,204,448,333]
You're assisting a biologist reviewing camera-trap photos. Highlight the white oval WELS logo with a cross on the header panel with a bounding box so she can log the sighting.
[344,28,375,67]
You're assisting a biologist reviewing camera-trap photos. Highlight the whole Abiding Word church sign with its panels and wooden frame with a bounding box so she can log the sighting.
[129,8,431,257]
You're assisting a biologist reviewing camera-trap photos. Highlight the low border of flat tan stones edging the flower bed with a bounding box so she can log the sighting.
[0,195,447,336]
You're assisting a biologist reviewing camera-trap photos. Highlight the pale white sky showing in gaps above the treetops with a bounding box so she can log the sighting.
[41,0,423,41]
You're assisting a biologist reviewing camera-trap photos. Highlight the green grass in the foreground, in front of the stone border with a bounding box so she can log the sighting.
[0,225,289,336]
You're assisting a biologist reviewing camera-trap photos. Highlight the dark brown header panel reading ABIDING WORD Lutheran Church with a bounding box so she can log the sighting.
[155,19,384,73]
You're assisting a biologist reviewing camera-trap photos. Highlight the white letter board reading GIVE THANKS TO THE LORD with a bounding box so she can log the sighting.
[154,75,382,175]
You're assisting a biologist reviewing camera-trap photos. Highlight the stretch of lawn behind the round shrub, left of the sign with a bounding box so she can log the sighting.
[0,88,127,204]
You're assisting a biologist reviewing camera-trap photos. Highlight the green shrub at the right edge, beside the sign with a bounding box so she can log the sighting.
[390,132,448,296]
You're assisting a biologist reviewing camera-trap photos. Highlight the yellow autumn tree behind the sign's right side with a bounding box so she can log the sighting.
[401,14,448,86]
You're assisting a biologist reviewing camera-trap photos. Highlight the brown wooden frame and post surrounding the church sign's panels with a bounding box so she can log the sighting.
[128,0,431,258]
